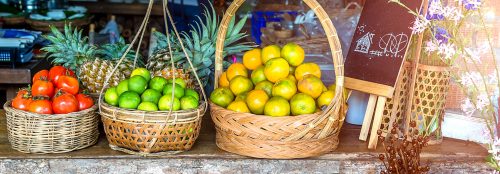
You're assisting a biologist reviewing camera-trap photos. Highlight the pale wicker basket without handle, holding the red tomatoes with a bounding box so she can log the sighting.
[4,101,99,153]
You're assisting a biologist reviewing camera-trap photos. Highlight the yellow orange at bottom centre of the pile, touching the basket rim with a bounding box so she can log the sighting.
[264,97,290,117]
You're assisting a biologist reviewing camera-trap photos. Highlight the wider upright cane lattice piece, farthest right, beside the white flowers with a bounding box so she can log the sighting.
[411,65,450,143]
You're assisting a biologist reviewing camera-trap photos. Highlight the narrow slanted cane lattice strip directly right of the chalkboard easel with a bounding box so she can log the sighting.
[380,62,411,135]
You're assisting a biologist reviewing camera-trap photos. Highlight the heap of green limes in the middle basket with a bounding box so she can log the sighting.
[104,68,200,111]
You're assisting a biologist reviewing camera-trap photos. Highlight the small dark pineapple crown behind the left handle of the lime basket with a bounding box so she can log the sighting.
[97,37,144,67]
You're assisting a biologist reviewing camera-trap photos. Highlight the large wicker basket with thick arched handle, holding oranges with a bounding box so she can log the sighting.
[210,0,346,159]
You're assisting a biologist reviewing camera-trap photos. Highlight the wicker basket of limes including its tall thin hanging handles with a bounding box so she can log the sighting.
[98,0,208,156]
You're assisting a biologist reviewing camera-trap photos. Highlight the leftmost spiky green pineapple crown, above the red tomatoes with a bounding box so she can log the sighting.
[42,24,97,71]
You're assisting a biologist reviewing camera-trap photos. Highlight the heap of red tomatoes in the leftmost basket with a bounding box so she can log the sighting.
[12,66,94,114]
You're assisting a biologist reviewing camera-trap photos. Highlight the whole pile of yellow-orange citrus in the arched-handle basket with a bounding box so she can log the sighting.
[210,43,335,116]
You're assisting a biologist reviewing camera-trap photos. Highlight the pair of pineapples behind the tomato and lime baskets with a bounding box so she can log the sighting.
[42,25,144,93]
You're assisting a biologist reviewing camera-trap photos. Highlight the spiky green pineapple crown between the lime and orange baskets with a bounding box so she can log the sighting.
[154,3,255,85]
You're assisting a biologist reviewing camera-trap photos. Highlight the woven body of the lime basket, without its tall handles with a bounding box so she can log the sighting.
[100,101,206,156]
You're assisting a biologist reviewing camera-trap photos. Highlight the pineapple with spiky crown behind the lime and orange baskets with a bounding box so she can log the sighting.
[146,3,254,86]
